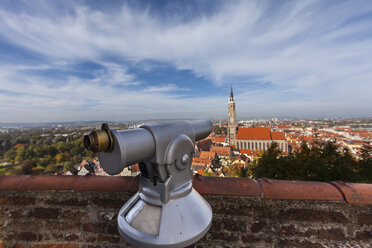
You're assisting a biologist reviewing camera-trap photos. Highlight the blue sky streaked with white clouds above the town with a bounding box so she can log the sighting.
[0,0,372,122]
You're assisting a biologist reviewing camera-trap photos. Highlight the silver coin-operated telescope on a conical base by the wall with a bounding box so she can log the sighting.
[84,121,212,247]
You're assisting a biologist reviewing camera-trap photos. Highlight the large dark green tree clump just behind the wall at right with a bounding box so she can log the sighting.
[253,142,364,182]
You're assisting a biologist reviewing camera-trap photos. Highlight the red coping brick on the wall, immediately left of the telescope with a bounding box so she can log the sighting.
[74,176,139,193]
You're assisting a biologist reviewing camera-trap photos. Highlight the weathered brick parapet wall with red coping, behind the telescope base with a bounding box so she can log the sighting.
[0,176,372,248]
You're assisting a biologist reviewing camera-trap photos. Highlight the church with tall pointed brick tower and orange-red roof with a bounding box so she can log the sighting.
[227,87,288,152]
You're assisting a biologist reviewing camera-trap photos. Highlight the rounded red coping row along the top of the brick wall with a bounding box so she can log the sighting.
[0,175,372,205]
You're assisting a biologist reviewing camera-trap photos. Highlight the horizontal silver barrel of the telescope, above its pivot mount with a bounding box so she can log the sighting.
[84,121,212,175]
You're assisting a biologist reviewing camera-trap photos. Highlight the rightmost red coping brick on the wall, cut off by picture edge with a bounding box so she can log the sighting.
[332,182,372,204]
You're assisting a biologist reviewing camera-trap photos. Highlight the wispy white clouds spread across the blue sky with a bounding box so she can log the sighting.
[0,1,372,121]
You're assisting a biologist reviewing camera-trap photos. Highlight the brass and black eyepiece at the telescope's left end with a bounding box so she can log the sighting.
[84,123,114,152]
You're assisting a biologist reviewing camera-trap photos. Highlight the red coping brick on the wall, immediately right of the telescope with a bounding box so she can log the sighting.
[193,175,261,196]
